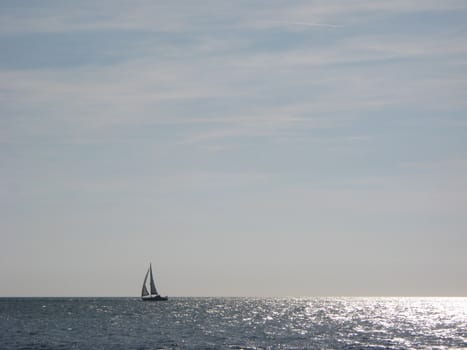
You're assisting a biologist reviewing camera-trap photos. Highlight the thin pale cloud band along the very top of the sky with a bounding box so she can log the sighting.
[0,0,466,35]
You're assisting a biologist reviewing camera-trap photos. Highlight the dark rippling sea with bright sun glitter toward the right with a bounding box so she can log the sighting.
[0,298,467,350]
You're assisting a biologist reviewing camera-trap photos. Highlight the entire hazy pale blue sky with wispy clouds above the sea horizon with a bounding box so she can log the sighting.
[0,0,467,296]
